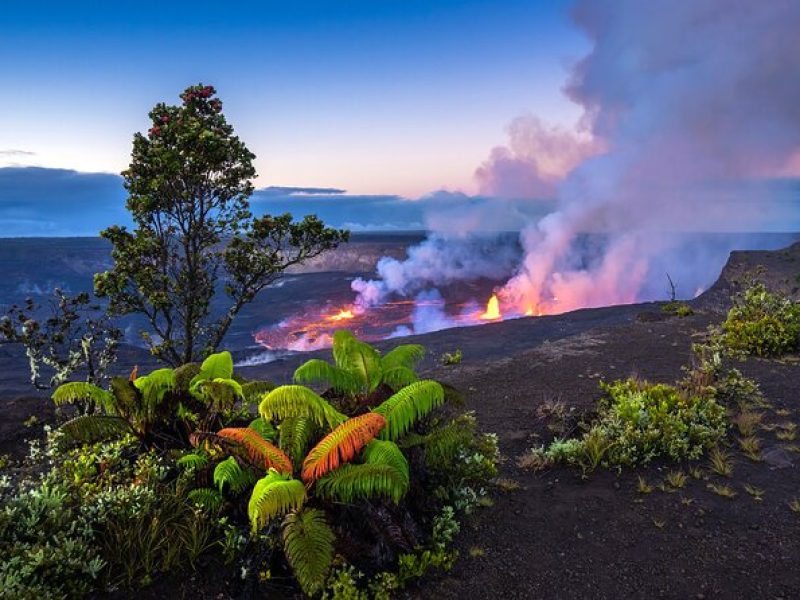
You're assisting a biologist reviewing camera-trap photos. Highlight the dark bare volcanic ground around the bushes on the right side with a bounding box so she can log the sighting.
[0,244,800,599]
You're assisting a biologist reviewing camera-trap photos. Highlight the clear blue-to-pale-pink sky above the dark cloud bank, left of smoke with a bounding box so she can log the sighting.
[0,0,589,198]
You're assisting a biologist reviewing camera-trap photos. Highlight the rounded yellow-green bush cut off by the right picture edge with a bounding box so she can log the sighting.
[722,283,800,356]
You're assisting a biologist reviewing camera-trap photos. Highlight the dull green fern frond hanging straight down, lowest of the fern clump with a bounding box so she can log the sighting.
[283,508,336,597]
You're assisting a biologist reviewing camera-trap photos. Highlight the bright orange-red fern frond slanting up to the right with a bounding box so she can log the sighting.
[303,413,386,482]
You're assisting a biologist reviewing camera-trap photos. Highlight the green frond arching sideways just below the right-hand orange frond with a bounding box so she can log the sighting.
[316,463,408,503]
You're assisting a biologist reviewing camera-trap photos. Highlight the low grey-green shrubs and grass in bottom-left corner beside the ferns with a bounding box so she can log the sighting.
[0,432,222,598]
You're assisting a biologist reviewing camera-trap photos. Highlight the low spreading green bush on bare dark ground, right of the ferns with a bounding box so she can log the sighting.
[542,379,727,470]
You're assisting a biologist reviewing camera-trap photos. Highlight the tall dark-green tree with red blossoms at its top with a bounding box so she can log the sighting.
[95,85,349,366]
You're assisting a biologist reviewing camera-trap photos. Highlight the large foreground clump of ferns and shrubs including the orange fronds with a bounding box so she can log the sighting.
[0,331,497,598]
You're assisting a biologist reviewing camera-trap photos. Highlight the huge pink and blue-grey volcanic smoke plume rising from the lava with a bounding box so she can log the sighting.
[258,0,800,352]
